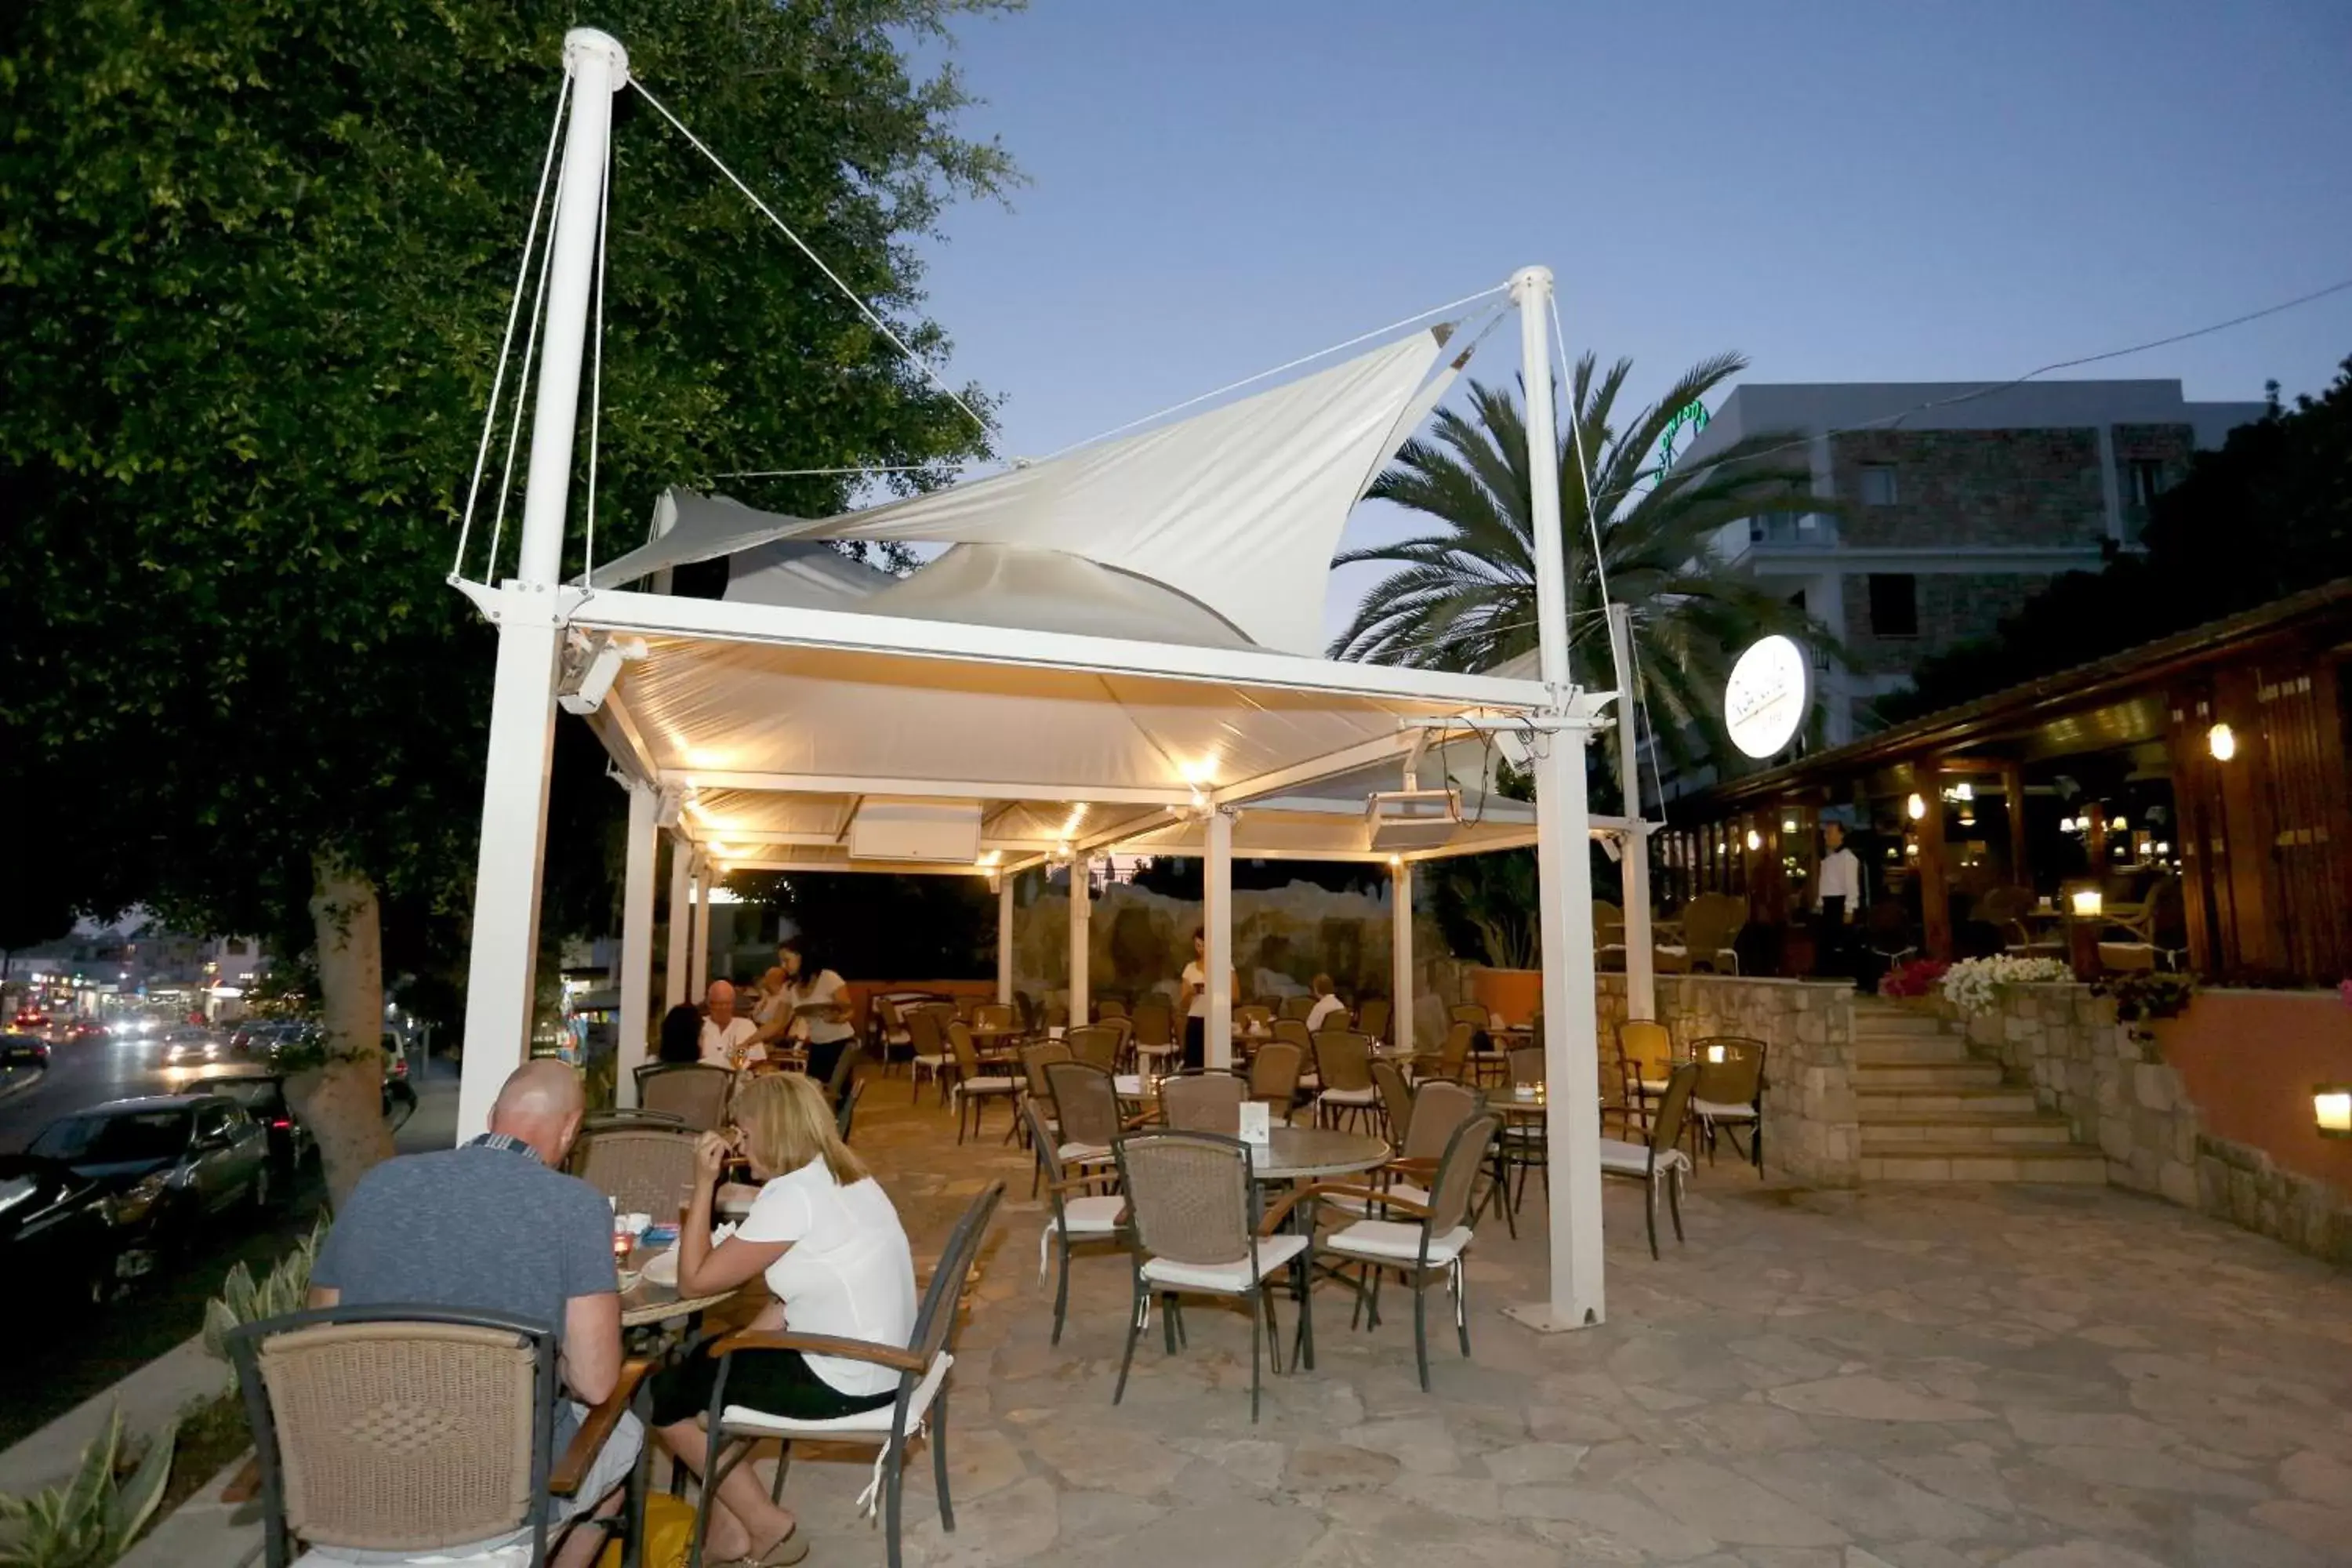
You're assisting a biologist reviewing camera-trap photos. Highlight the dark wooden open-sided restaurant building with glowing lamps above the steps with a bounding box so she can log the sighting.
[1653,579,2352,985]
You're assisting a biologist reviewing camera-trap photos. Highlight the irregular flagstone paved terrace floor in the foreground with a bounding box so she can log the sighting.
[757,1079,2352,1568]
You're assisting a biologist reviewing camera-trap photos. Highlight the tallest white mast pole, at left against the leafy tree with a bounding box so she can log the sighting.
[456,28,628,1140]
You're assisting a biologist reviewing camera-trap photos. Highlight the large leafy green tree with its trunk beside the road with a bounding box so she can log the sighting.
[0,0,1009,1196]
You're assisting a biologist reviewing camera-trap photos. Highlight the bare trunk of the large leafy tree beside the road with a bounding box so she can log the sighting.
[287,851,393,1208]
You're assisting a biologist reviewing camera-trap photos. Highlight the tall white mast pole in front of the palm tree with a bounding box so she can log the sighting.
[1510,268,1602,1330]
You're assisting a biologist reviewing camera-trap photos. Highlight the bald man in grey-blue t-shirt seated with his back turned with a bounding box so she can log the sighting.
[310,1060,644,1568]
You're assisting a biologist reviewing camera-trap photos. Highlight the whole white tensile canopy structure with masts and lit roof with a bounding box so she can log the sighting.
[459,28,1637,1326]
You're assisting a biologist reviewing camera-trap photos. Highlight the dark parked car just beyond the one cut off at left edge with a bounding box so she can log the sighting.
[26,1093,278,1258]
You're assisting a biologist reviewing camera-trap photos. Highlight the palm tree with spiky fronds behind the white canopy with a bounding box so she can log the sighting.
[1331,355,1837,762]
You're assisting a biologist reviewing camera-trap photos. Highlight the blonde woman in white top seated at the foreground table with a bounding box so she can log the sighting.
[654,1072,915,1568]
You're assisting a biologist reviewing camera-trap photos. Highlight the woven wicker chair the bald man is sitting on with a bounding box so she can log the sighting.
[228,1307,652,1568]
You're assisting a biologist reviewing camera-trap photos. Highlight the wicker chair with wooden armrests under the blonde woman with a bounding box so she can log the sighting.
[687,1182,1004,1568]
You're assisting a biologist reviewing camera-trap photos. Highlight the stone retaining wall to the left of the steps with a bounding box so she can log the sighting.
[1599,975,1863,1187]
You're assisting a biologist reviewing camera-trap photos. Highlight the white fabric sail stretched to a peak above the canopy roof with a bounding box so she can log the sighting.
[593,329,1458,656]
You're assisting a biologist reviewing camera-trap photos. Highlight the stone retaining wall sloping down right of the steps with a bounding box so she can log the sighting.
[1969,982,2352,1262]
